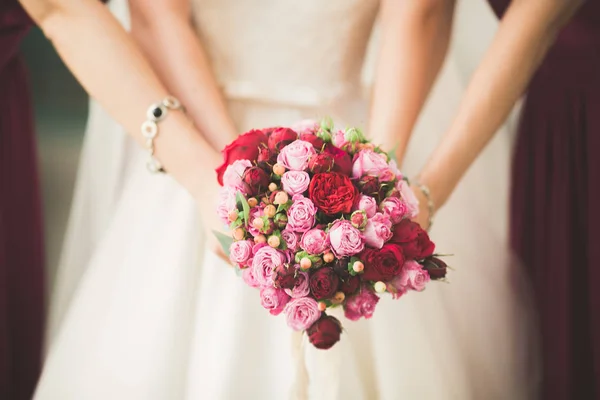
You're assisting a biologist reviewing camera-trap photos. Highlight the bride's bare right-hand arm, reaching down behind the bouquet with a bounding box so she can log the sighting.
[368,0,455,163]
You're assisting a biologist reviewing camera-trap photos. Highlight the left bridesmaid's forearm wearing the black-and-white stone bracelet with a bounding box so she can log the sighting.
[21,0,219,199]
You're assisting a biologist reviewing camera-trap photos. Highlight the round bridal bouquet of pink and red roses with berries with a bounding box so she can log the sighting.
[217,120,446,349]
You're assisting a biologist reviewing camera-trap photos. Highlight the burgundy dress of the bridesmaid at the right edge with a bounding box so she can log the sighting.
[490,0,600,400]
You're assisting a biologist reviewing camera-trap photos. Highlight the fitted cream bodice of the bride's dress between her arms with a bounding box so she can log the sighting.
[193,0,378,105]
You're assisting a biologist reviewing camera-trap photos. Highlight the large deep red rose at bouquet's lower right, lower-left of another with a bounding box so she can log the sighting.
[360,243,404,282]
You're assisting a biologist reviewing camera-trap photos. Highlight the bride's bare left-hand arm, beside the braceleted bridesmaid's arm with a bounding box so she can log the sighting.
[129,0,237,150]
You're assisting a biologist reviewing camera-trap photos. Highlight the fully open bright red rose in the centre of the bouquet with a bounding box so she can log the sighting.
[308,172,358,215]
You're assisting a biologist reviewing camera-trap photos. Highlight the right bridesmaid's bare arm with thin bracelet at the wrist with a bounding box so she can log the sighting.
[419,0,583,227]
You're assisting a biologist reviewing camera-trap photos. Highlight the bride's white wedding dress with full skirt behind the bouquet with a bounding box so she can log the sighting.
[35,0,536,400]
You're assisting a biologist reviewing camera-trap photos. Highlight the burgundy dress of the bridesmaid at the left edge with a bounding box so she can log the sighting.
[0,0,44,400]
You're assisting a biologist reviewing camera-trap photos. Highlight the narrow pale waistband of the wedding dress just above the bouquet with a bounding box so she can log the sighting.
[221,81,361,108]
